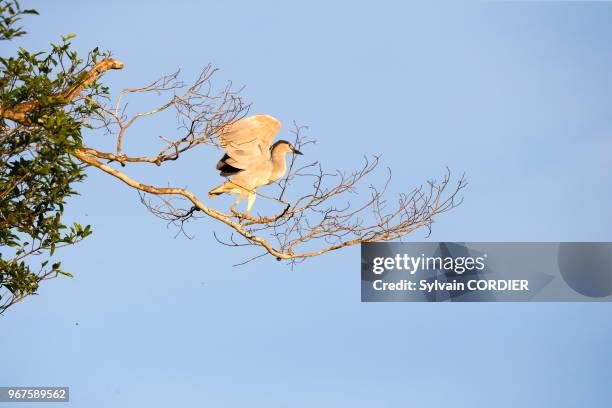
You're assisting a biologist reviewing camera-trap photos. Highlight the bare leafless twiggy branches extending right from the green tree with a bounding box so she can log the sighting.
[76,66,466,264]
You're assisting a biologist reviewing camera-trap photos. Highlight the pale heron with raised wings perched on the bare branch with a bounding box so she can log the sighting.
[208,115,302,213]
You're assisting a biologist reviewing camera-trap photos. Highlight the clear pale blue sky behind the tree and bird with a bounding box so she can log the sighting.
[0,1,612,408]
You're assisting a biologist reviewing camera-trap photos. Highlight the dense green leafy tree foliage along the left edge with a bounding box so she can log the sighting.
[0,1,107,313]
